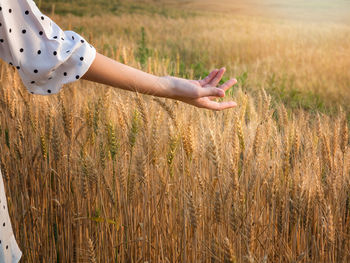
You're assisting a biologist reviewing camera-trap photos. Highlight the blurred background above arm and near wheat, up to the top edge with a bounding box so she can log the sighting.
[38,0,350,112]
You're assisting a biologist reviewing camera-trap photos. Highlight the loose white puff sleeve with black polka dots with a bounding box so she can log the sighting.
[0,0,96,95]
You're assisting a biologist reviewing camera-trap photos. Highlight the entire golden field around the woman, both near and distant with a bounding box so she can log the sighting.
[0,0,350,263]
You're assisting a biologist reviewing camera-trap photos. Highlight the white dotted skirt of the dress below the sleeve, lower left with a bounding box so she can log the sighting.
[0,170,22,263]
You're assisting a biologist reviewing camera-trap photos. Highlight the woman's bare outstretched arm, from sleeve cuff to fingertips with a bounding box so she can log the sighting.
[82,53,237,110]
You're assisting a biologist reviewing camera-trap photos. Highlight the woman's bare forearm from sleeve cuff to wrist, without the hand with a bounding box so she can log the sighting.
[82,53,173,98]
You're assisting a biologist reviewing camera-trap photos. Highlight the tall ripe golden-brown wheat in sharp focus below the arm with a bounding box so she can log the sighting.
[0,58,350,262]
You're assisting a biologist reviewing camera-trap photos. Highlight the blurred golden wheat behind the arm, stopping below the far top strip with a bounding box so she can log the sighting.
[49,9,350,113]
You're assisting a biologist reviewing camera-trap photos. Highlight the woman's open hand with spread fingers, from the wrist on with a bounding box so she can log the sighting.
[162,68,237,110]
